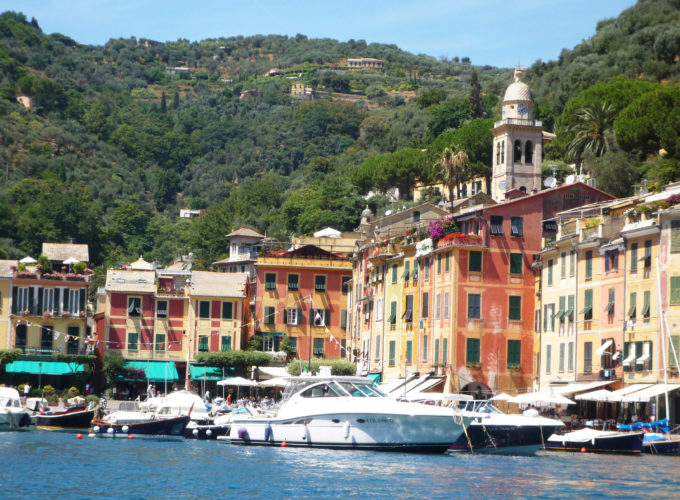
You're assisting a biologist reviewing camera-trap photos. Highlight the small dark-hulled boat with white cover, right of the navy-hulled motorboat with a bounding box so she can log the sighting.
[545,428,644,454]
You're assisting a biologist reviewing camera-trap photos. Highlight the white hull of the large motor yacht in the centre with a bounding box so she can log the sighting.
[230,413,467,453]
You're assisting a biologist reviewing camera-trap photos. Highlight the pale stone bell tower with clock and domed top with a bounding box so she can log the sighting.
[491,68,543,202]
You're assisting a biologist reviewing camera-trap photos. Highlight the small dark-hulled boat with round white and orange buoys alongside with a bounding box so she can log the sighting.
[90,414,190,440]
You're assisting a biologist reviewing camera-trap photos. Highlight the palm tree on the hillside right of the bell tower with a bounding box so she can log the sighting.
[567,101,617,172]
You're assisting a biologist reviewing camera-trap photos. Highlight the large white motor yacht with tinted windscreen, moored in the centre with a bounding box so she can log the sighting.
[230,376,470,453]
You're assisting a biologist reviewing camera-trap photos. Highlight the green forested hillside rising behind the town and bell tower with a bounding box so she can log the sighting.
[0,0,680,278]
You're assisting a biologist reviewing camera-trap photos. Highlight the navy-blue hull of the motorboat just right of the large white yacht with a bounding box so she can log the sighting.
[451,421,562,454]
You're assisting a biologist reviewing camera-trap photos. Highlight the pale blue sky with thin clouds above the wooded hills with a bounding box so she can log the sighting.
[0,0,635,67]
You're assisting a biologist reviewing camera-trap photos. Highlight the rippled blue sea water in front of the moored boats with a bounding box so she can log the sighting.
[0,431,680,499]
